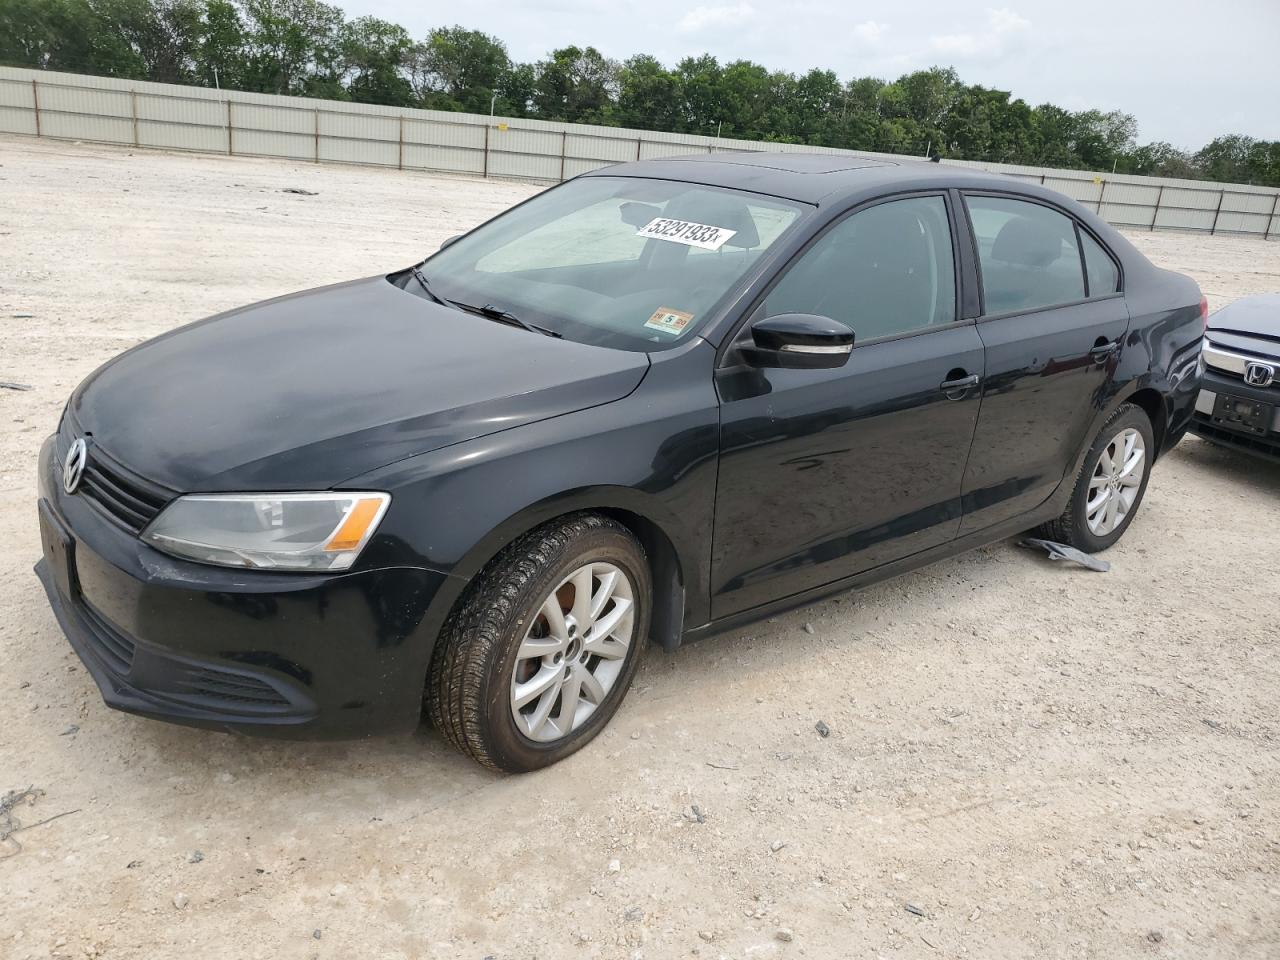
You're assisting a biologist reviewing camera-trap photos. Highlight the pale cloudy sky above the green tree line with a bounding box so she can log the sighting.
[337,0,1280,148]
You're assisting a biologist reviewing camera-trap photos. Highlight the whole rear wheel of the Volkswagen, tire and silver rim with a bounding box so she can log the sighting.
[1036,403,1155,553]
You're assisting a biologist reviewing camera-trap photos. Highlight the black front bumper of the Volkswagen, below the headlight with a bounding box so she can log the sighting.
[36,438,448,739]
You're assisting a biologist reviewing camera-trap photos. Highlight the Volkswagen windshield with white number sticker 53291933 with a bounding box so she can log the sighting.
[422,177,805,351]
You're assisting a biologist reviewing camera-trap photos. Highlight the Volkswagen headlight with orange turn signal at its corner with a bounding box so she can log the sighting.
[142,493,392,571]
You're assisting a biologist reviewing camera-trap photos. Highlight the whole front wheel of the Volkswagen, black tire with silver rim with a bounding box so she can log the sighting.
[425,513,653,773]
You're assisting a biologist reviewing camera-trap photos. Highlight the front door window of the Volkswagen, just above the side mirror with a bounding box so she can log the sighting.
[764,197,956,342]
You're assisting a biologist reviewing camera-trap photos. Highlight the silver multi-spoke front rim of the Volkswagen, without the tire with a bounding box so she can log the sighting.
[511,563,635,742]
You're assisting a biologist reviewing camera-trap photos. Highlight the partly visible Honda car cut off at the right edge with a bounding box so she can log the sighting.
[1192,293,1280,462]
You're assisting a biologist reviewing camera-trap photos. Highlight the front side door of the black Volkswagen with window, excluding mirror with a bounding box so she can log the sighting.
[712,193,983,618]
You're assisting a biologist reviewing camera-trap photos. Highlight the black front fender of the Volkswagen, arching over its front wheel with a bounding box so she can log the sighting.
[344,344,719,665]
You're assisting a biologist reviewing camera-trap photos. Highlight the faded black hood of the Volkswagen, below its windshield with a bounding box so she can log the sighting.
[70,276,649,493]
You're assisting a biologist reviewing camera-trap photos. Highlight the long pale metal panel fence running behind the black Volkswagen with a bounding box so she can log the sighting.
[0,67,1280,239]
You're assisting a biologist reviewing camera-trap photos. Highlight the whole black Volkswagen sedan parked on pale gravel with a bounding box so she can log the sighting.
[37,154,1204,771]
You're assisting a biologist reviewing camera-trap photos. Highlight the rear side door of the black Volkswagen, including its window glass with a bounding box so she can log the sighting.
[960,193,1129,535]
